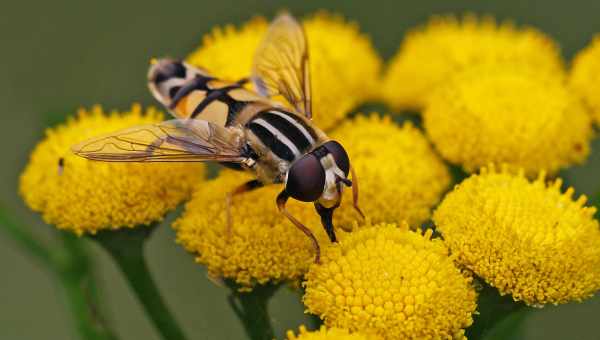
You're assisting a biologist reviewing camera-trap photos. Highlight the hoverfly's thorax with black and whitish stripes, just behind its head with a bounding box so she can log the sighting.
[246,109,323,163]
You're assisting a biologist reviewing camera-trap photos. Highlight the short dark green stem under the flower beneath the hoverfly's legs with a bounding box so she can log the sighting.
[226,281,279,340]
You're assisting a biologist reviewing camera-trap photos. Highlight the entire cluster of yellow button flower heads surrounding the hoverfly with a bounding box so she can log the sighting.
[20,12,600,340]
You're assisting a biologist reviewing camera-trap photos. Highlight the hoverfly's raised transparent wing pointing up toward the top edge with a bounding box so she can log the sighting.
[252,13,312,118]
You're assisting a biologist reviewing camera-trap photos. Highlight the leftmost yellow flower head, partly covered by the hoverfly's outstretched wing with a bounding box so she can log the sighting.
[20,105,204,235]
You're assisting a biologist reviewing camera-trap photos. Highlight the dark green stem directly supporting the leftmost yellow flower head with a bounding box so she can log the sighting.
[92,225,185,340]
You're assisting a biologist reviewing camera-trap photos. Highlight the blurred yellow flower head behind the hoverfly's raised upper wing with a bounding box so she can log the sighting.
[187,12,382,129]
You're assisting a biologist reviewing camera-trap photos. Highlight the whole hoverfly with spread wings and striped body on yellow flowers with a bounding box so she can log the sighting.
[73,13,364,262]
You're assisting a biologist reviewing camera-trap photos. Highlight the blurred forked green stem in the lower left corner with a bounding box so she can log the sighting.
[0,206,116,340]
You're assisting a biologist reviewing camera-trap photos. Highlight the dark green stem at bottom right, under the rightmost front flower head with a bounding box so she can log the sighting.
[466,284,526,340]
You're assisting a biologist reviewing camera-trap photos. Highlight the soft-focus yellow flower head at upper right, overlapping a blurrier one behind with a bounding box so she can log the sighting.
[423,65,592,175]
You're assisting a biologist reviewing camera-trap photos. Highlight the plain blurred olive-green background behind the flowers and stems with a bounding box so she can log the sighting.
[0,0,600,340]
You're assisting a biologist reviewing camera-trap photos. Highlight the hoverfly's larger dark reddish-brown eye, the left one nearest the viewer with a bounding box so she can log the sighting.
[285,154,325,202]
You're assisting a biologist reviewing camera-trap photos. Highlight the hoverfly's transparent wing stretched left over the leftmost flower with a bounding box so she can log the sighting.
[72,119,246,162]
